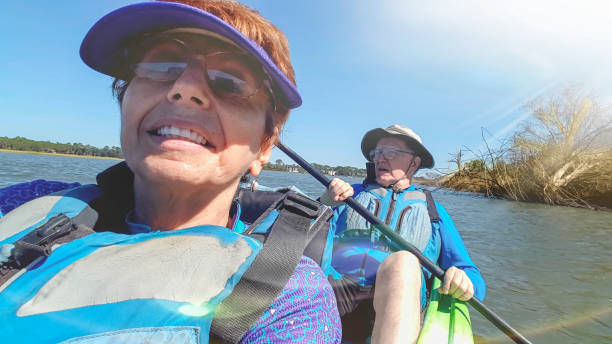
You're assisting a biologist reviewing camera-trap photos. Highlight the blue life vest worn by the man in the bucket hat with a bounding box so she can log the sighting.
[332,184,441,286]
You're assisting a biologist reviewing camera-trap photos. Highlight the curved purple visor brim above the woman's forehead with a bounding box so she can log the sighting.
[80,2,302,109]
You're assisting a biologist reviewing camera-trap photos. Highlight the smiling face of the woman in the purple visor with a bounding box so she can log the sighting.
[121,32,272,191]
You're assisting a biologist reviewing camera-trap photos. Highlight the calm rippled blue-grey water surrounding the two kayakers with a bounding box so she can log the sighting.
[0,153,612,344]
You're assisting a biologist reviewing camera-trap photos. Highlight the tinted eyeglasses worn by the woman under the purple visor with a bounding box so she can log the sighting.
[126,33,276,105]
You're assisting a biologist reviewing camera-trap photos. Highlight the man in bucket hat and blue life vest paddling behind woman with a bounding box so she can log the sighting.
[321,124,486,343]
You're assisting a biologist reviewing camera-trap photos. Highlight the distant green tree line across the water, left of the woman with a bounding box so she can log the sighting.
[0,136,123,158]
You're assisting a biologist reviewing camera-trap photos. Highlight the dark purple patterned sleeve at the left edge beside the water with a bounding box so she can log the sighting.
[0,179,81,216]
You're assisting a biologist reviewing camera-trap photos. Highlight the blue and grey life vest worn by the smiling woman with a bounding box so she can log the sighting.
[0,165,331,344]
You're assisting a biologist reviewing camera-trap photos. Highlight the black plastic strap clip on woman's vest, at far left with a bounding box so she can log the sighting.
[10,214,78,269]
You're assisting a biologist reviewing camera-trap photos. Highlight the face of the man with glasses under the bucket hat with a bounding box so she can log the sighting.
[374,137,419,187]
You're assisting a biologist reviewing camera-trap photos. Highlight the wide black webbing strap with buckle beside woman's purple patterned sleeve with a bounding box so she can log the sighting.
[211,192,319,343]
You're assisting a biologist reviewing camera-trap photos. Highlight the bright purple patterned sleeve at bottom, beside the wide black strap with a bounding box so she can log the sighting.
[241,257,342,343]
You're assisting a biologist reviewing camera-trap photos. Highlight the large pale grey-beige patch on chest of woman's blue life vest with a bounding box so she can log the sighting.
[17,227,261,316]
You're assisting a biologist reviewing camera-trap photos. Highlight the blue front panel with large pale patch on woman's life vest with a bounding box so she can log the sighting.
[0,226,262,343]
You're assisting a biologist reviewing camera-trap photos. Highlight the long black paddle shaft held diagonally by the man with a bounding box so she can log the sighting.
[276,141,531,344]
